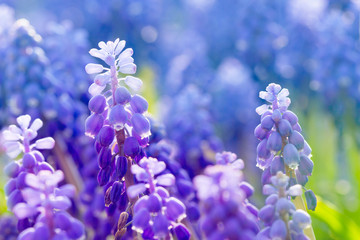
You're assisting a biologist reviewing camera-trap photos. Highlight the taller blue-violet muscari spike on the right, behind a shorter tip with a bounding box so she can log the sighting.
[254,83,314,210]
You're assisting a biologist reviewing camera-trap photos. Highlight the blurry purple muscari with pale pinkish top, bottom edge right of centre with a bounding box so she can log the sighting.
[194,165,259,239]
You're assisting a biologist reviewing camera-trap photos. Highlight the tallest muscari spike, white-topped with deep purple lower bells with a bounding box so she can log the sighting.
[85,39,151,238]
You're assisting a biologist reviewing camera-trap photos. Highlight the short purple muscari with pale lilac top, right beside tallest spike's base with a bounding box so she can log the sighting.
[127,157,190,240]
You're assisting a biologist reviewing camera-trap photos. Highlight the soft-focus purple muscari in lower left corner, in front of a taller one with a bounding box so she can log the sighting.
[12,171,85,240]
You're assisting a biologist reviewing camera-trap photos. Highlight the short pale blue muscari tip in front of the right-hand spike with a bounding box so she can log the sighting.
[257,171,311,240]
